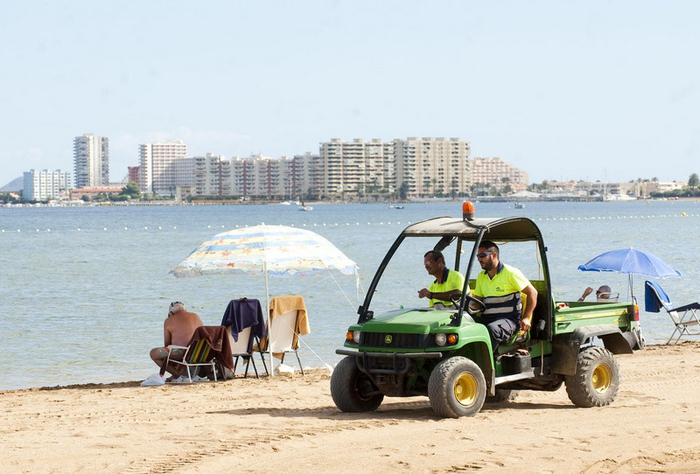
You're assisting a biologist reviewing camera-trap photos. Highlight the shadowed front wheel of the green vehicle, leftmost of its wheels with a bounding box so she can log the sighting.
[331,356,384,413]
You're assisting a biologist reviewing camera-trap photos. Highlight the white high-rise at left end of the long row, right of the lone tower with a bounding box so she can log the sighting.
[139,140,194,195]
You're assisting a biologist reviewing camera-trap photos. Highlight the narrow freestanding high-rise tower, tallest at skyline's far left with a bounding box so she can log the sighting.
[73,133,109,188]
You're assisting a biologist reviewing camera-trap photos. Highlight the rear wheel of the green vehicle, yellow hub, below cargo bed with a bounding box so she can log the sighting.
[565,347,620,408]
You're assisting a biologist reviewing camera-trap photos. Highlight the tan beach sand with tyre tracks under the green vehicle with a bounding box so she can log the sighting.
[0,342,700,473]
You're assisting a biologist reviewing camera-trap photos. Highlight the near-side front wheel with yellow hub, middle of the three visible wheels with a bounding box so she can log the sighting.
[428,357,486,418]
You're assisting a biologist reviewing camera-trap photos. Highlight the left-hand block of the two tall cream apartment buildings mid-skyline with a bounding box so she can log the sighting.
[319,138,396,196]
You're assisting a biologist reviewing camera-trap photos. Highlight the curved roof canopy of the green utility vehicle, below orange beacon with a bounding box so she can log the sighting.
[402,217,542,241]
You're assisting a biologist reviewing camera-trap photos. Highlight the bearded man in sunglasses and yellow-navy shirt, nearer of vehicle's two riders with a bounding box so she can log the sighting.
[474,240,537,351]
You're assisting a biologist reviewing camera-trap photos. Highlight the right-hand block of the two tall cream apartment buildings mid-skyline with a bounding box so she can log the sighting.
[394,138,470,197]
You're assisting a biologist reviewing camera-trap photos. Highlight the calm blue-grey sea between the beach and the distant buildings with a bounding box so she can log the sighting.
[0,201,700,390]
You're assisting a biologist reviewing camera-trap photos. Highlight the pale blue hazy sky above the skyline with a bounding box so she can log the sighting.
[0,0,700,186]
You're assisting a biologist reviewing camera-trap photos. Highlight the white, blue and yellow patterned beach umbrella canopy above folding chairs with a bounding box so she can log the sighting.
[170,225,357,278]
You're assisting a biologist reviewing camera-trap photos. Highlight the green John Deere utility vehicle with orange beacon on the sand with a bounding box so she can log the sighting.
[331,202,644,418]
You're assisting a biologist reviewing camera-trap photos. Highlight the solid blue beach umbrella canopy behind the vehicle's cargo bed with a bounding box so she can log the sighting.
[578,248,681,278]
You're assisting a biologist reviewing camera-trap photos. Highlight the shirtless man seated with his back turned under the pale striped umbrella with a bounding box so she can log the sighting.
[151,301,204,378]
